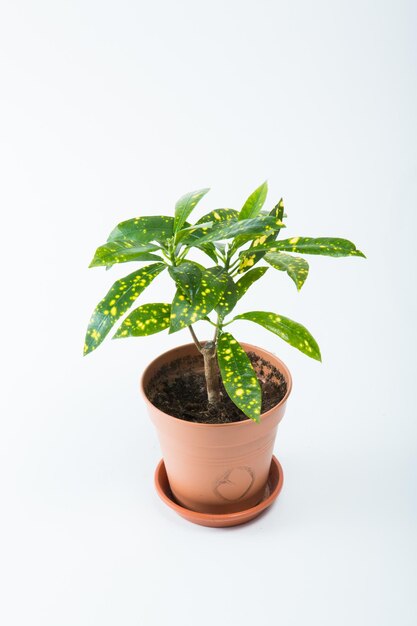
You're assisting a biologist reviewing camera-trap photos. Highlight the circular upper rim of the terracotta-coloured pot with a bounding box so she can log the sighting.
[140,342,292,428]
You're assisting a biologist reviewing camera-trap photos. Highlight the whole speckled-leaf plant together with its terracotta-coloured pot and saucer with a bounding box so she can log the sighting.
[84,182,364,525]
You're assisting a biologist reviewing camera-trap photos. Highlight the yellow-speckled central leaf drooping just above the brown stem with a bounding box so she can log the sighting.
[169,268,227,333]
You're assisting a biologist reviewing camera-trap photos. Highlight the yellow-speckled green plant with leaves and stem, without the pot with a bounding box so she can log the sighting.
[84,182,364,421]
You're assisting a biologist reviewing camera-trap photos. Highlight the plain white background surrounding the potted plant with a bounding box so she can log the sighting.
[0,0,417,626]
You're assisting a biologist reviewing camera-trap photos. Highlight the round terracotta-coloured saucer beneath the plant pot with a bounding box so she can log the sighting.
[155,456,284,528]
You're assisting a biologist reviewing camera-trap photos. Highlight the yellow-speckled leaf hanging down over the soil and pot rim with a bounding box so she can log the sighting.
[217,333,262,422]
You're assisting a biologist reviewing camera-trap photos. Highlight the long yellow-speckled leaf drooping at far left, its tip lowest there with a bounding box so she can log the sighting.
[84,263,166,354]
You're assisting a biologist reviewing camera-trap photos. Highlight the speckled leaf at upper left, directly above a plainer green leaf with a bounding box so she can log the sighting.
[107,215,174,244]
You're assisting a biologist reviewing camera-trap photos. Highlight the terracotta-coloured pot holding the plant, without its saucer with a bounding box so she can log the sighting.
[141,343,292,514]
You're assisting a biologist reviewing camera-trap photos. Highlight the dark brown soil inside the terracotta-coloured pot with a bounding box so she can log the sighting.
[146,352,287,424]
